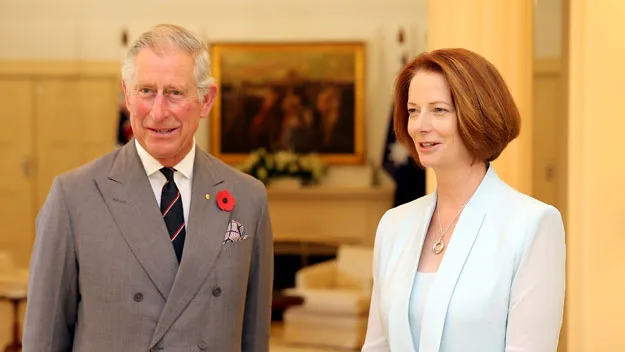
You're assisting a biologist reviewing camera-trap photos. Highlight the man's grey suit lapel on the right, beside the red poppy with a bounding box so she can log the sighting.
[151,148,232,347]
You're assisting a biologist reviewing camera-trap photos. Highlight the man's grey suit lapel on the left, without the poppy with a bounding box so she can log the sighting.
[96,141,178,299]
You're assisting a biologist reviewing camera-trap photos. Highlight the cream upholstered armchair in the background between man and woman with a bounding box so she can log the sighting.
[283,245,373,349]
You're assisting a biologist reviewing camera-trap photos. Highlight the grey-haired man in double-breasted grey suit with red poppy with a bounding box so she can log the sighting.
[23,25,273,352]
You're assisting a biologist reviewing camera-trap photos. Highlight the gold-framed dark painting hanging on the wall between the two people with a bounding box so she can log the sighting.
[210,42,365,164]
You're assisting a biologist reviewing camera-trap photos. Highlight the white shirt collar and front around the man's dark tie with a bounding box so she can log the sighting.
[135,139,195,224]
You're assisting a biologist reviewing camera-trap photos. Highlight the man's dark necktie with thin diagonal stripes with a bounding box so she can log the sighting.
[161,167,186,263]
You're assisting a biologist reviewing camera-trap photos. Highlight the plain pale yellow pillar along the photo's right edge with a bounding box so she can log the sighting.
[566,0,625,352]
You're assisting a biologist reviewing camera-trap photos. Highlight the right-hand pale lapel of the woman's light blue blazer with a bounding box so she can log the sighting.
[420,199,486,352]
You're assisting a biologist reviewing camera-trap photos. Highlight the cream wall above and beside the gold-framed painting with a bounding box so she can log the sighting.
[0,0,427,164]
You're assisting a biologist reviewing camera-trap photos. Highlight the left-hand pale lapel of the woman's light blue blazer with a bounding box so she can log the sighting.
[388,193,436,352]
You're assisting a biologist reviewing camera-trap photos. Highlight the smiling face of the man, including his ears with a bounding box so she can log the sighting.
[122,47,217,167]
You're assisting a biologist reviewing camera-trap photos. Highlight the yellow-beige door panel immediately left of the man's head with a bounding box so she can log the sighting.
[36,77,119,208]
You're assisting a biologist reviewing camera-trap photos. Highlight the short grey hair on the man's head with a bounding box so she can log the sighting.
[122,24,213,102]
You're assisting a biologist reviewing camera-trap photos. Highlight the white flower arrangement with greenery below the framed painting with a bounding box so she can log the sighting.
[237,149,326,185]
